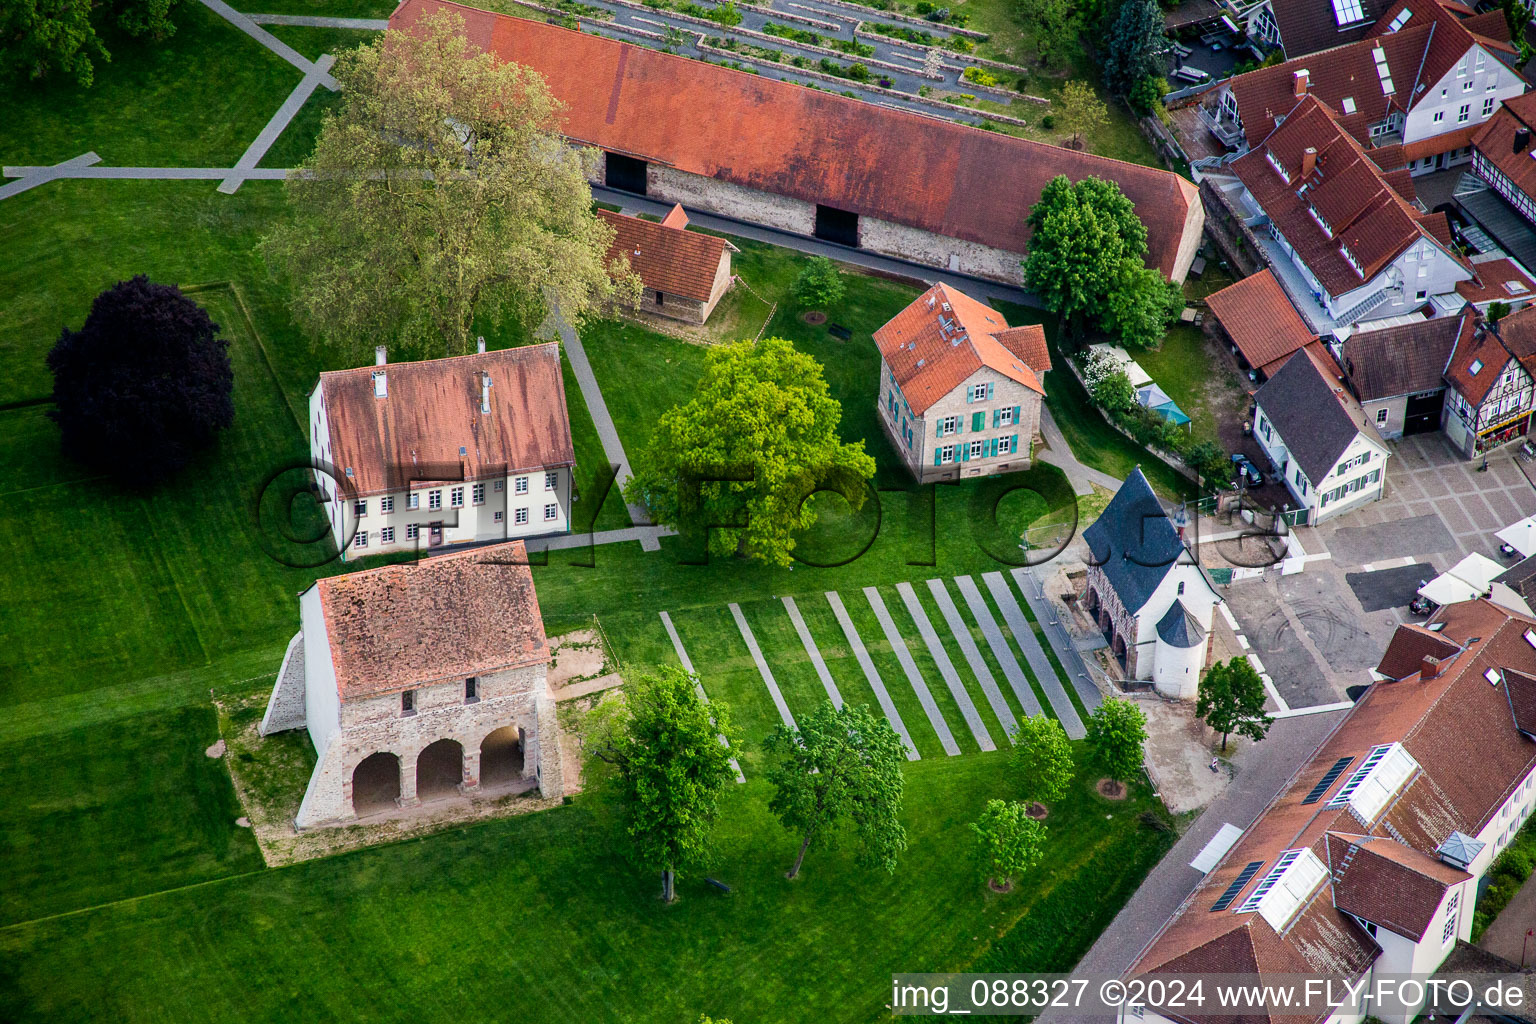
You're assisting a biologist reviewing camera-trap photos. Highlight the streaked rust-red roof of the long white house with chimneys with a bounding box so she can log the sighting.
[318,342,576,496]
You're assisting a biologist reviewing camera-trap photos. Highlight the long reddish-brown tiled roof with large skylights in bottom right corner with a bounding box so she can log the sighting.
[1132,600,1536,1024]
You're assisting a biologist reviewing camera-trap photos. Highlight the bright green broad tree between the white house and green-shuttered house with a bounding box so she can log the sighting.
[624,338,874,565]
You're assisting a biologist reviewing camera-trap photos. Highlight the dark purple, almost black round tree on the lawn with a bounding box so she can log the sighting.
[48,275,235,484]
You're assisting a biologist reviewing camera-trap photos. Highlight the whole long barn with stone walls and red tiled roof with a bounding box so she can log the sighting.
[390,0,1204,284]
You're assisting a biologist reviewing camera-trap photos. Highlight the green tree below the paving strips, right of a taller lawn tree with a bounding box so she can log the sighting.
[768,700,906,878]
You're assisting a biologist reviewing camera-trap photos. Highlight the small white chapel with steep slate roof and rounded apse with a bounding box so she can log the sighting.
[1083,467,1221,700]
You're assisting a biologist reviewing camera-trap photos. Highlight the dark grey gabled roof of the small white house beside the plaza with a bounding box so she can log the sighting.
[1253,350,1379,487]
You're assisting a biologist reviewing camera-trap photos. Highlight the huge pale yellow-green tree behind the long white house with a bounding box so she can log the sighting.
[263,11,639,358]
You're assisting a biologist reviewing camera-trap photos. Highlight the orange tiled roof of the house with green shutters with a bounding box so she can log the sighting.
[874,284,1051,416]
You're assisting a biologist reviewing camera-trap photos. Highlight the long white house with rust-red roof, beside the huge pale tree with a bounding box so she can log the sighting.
[309,342,576,560]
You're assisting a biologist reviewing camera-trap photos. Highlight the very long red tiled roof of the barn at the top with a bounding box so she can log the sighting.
[390,0,1203,276]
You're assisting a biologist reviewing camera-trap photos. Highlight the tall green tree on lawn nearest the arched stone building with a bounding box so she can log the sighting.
[582,666,736,903]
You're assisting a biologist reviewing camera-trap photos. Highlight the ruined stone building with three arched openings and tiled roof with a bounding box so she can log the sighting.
[261,540,564,829]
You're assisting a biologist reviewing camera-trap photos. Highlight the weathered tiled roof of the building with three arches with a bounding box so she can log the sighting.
[315,540,550,702]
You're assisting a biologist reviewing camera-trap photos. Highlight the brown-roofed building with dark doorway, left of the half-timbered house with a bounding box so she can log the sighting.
[1339,310,1478,441]
